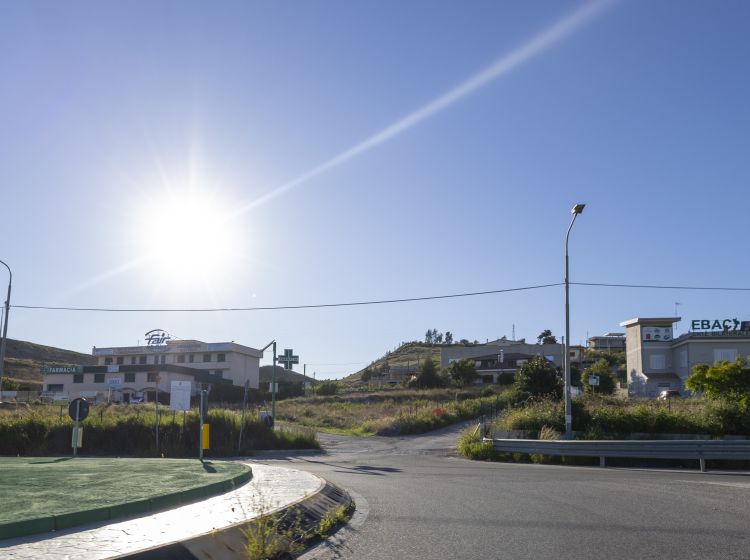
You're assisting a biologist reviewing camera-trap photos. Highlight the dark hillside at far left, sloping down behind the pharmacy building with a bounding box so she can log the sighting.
[5,338,96,391]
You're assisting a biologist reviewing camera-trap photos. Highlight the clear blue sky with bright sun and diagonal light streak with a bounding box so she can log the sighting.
[0,1,750,377]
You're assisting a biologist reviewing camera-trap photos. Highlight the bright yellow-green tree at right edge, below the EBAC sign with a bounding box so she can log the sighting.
[685,356,750,407]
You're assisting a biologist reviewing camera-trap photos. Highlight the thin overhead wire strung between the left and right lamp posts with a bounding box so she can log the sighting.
[11,282,563,313]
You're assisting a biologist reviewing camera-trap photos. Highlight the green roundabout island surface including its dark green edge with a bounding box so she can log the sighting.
[0,457,252,539]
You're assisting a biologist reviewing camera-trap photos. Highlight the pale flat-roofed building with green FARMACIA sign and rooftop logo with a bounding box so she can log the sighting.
[43,337,263,402]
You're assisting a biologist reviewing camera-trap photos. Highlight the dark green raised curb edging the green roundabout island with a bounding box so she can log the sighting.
[0,467,253,540]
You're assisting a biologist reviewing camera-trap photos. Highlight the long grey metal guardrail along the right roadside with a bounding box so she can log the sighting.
[484,438,750,472]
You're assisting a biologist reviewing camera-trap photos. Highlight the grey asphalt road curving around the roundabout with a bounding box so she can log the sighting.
[261,427,750,560]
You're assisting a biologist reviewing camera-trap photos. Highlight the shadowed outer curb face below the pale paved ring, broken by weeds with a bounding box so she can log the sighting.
[115,481,353,560]
